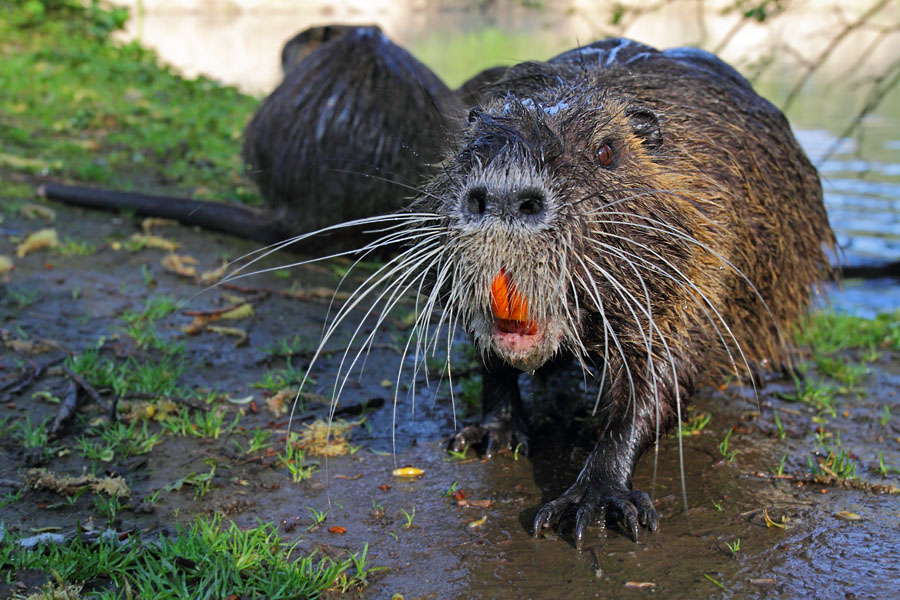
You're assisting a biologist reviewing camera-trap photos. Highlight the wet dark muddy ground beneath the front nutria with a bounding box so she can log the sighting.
[0,199,900,599]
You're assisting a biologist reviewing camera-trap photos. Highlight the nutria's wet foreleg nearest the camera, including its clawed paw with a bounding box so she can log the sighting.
[533,390,659,550]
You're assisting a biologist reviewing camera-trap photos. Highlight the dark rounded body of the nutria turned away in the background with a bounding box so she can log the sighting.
[243,26,463,249]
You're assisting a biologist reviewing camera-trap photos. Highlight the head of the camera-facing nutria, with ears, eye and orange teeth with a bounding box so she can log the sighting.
[424,66,708,371]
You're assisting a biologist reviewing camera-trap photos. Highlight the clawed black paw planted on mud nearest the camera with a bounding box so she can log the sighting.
[534,482,659,550]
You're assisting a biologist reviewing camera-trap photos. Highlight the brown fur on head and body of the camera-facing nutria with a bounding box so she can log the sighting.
[422,47,834,390]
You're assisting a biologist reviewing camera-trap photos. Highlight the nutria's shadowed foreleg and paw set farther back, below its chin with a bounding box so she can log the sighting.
[450,357,528,458]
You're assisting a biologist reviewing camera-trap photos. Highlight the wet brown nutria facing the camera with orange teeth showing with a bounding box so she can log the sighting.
[312,39,834,547]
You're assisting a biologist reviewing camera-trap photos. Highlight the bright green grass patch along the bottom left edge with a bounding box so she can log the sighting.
[0,516,374,600]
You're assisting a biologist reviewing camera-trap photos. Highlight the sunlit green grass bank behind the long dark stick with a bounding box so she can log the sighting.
[0,0,258,203]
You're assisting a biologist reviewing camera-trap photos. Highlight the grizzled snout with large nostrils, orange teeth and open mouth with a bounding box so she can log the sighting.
[448,165,571,371]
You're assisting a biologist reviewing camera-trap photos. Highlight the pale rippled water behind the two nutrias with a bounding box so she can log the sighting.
[114,0,900,314]
